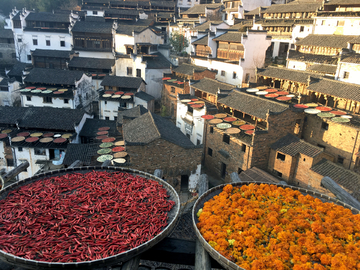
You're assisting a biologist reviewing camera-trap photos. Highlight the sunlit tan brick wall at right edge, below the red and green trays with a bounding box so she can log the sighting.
[303,115,360,169]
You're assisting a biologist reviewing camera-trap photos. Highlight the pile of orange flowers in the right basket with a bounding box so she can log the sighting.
[197,184,360,270]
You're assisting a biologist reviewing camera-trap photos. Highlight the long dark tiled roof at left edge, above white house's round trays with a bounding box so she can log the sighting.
[0,106,85,131]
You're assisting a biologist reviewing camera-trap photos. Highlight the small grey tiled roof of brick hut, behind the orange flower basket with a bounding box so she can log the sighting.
[271,133,323,158]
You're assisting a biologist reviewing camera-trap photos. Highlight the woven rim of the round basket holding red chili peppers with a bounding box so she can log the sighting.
[0,166,180,270]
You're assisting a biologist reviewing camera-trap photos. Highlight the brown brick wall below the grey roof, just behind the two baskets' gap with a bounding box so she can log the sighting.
[126,139,203,178]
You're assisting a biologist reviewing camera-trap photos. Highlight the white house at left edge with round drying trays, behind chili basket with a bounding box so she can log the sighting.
[0,107,90,179]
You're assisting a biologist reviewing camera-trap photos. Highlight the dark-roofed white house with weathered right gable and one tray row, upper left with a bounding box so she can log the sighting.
[20,68,96,111]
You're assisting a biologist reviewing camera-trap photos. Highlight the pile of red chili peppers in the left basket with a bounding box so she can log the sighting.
[0,171,175,262]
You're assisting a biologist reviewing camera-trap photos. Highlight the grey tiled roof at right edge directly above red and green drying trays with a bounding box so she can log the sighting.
[307,78,360,104]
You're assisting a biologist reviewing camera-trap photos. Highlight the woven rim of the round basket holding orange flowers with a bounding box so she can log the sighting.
[192,182,360,270]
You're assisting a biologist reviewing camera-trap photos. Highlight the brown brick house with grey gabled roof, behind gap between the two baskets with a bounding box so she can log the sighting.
[122,112,202,185]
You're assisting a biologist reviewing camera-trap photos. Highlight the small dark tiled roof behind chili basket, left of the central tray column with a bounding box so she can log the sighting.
[63,143,99,166]
